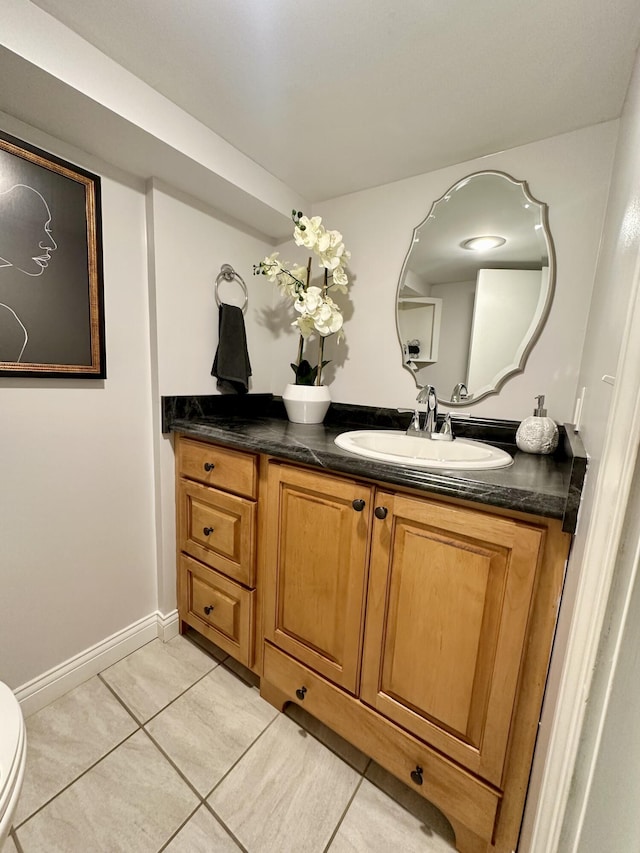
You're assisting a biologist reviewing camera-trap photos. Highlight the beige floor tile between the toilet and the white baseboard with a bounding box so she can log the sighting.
[14,677,138,826]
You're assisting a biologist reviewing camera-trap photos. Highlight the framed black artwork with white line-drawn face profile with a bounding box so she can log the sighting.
[0,131,106,379]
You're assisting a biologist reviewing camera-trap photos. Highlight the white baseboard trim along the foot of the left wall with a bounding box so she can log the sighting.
[15,610,179,717]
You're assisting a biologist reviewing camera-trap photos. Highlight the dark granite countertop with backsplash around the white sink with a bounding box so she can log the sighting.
[162,394,587,533]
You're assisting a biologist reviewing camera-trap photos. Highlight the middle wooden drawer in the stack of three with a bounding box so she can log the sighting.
[178,480,256,587]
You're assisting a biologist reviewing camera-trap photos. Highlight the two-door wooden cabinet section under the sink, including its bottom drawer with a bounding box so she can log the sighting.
[261,463,569,853]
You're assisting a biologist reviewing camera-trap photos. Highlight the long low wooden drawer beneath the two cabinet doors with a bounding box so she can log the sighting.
[263,643,501,842]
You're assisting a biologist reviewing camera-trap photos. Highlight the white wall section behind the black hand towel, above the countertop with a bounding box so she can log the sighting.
[149,183,274,394]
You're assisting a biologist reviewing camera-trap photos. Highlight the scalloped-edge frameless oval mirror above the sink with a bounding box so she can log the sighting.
[396,172,555,406]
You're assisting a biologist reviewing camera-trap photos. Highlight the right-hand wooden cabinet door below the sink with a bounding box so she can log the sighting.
[361,492,544,785]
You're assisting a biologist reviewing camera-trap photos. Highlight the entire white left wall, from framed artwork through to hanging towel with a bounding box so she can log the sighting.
[0,116,279,688]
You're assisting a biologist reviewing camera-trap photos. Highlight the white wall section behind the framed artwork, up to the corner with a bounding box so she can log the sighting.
[0,115,157,688]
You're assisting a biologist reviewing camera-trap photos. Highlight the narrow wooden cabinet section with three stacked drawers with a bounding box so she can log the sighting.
[176,436,258,667]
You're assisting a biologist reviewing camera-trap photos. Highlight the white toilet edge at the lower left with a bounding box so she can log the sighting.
[0,681,27,850]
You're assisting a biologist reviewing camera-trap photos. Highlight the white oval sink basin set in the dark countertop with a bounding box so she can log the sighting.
[335,429,513,471]
